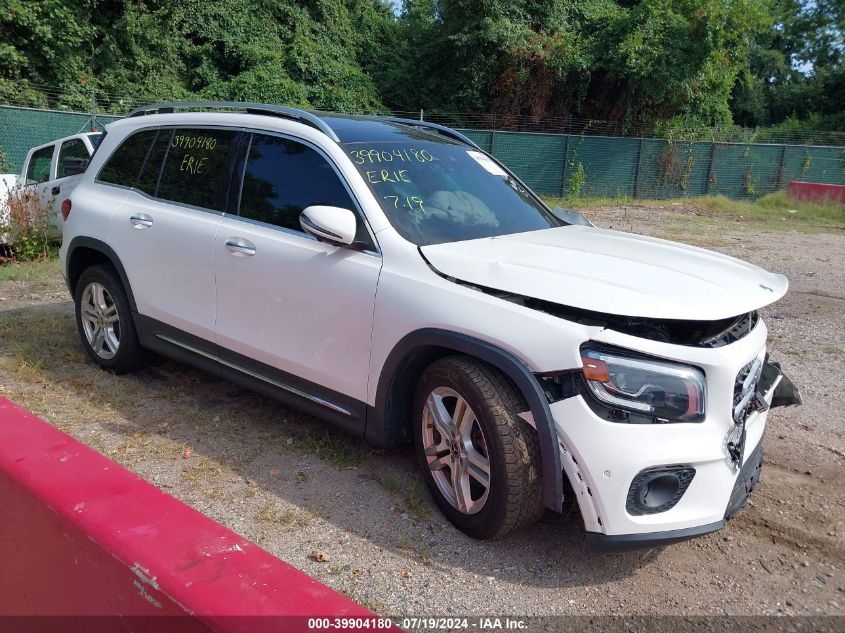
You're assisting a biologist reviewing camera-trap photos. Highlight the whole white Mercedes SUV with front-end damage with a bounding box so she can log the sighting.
[61,102,800,549]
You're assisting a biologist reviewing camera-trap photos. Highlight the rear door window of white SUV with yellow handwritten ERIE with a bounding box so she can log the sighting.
[156,128,240,211]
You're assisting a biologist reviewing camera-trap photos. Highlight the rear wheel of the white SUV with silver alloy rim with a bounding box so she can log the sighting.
[74,264,148,374]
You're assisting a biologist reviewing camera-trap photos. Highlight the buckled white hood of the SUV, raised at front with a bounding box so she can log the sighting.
[420,226,789,321]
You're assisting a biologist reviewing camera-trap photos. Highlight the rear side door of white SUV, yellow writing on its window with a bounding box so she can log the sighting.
[103,127,241,346]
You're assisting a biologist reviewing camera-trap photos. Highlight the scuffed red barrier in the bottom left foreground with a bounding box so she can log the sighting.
[0,398,396,633]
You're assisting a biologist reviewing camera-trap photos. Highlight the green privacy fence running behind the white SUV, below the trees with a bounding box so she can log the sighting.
[0,106,845,198]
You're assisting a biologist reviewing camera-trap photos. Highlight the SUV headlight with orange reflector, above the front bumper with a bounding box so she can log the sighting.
[581,346,704,422]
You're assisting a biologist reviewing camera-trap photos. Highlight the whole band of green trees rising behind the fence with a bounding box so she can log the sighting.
[0,0,845,131]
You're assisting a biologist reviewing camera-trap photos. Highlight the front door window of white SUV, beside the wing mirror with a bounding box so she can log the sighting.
[240,134,361,234]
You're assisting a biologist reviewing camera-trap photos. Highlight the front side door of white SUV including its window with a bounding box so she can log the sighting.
[214,128,381,430]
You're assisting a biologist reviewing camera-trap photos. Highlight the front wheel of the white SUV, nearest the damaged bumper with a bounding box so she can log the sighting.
[413,356,543,539]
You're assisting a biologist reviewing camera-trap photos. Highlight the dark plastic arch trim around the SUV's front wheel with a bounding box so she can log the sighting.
[365,328,563,512]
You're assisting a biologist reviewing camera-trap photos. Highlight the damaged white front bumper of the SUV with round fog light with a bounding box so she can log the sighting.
[550,327,801,552]
